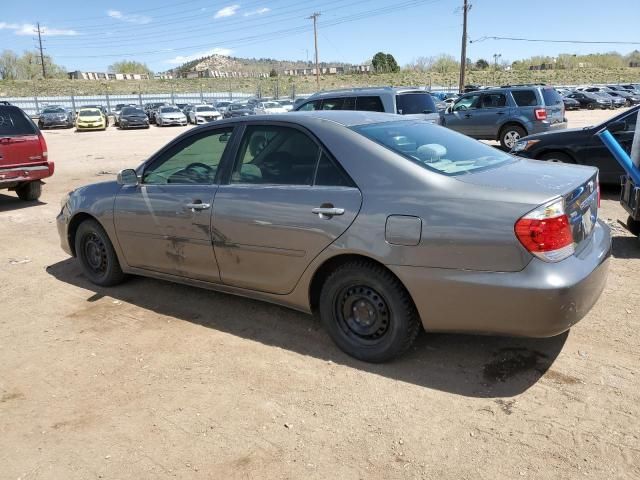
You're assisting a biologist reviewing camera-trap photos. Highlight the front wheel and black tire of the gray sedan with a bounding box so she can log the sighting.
[75,220,125,287]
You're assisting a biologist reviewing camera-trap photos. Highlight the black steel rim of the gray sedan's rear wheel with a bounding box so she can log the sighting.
[335,285,392,345]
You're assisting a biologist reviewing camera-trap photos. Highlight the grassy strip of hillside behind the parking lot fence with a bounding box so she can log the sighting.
[0,68,640,98]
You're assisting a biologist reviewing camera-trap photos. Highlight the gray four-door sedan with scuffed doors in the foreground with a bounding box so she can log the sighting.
[57,111,611,362]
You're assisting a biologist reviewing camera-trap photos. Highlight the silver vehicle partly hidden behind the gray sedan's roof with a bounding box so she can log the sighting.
[295,87,442,124]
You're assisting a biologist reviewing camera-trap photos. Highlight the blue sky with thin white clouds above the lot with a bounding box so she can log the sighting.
[0,0,640,71]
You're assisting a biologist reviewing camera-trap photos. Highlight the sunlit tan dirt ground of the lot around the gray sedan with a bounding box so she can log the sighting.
[0,111,640,480]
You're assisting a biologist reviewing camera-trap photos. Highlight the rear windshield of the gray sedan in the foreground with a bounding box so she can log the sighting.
[352,121,514,176]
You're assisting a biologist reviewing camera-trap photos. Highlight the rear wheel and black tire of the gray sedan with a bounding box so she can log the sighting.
[319,260,421,363]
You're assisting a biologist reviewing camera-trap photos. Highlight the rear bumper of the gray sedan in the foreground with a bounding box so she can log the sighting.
[389,221,611,337]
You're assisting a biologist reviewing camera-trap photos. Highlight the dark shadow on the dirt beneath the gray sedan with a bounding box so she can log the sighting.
[47,259,568,398]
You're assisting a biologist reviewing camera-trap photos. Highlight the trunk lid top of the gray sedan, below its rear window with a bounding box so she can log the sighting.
[455,157,597,204]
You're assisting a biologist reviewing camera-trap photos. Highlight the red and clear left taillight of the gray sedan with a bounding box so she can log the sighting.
[515,200,575,262]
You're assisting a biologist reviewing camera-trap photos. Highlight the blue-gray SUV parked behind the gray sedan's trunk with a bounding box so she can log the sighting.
[443,86,567,150]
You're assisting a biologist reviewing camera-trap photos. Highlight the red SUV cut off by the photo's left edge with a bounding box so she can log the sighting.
[0,105,54,201]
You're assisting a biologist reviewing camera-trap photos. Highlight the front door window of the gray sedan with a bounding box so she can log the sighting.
[142,127,233,185]
